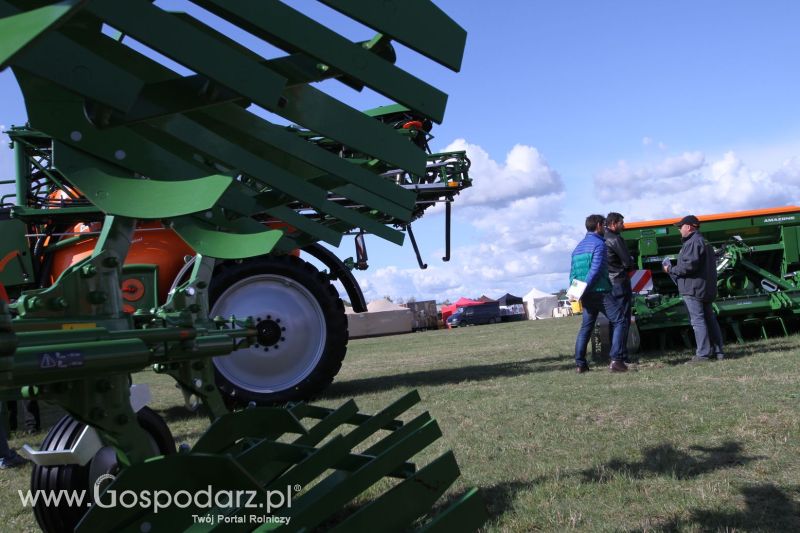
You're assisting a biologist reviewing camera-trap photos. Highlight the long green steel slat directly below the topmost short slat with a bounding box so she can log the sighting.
[193,0,447,122]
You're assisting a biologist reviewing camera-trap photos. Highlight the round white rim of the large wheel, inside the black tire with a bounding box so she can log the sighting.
[211,274,327,393]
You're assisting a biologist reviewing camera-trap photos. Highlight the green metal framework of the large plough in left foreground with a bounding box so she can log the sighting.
[0,0,486,531]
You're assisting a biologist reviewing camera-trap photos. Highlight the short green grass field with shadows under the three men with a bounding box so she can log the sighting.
[0,318,800,532]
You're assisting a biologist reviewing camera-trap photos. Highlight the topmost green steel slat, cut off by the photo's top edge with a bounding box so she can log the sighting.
[319,0,467,71]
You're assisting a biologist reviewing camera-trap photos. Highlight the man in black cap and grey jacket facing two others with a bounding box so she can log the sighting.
[664,215,725,363]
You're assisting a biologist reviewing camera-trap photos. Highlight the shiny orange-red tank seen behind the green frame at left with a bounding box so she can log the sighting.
[50,222,194,302]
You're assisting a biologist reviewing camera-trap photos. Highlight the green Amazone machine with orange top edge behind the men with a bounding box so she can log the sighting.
[620,206,800,349]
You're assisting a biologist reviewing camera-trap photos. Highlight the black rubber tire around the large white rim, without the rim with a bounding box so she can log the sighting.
[209,255,348,406]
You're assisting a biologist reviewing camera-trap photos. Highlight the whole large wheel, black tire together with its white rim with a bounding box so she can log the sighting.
[209,255,348,406]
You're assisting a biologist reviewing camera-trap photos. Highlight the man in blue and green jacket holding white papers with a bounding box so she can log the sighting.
[569,215,628,374]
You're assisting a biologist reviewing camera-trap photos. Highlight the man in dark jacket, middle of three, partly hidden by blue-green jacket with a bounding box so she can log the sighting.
[605,212,633,363]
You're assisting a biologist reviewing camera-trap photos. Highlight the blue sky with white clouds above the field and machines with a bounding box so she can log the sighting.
[0,0,800,300]
